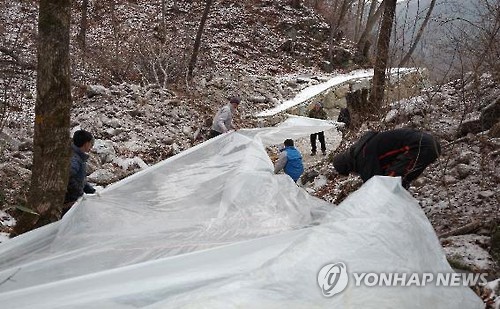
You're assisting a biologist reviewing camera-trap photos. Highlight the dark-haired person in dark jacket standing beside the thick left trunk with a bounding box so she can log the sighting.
[64,130,95,211]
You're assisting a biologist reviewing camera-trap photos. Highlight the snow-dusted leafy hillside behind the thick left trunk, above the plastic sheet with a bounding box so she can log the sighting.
[0,1,349,207]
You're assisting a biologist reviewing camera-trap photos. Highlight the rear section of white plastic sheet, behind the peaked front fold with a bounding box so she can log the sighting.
[0,120,332,298]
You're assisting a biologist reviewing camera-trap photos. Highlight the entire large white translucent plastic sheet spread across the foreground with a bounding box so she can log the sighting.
[0,117,482,309]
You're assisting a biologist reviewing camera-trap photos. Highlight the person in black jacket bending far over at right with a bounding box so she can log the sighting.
[333,129,441,189]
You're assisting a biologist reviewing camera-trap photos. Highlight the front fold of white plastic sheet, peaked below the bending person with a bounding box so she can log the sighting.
[0,177,484,309]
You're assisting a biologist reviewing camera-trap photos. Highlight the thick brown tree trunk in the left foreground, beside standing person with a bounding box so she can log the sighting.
[12,0,71,236]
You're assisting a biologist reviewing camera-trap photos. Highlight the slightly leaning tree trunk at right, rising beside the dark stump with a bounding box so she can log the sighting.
[369,0,396,110]
